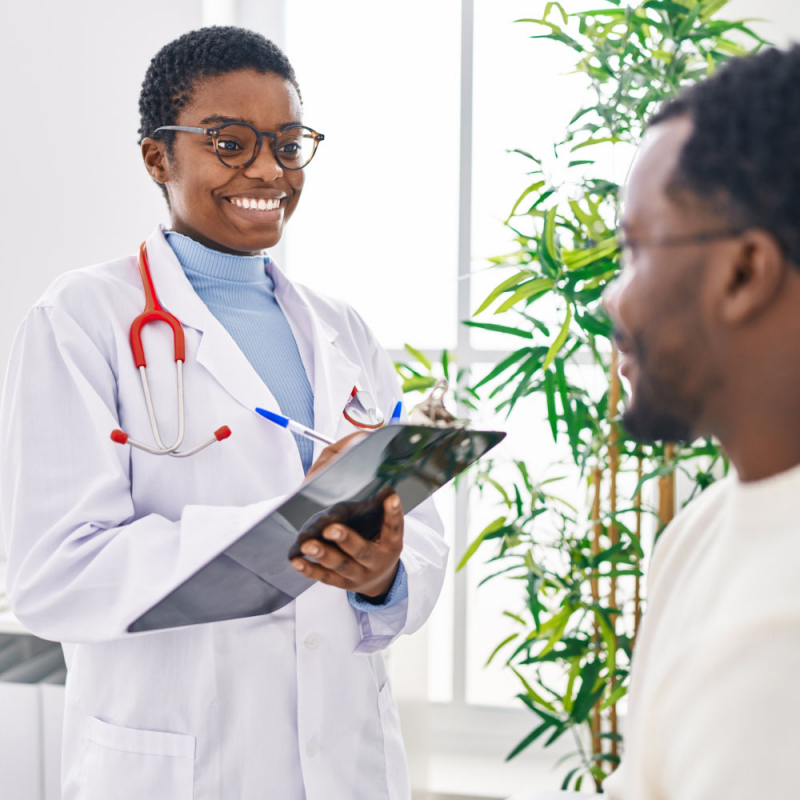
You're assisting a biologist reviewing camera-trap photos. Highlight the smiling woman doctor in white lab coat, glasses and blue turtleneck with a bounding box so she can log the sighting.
[0,28,446,800]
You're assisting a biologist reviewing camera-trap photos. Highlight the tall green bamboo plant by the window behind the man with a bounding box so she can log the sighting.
[398,0,765,791]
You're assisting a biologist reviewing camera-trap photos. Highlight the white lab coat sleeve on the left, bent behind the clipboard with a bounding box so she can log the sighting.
[0,306,288,642]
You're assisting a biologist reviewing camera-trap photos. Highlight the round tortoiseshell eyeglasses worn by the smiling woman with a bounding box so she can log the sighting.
[154,122,325,170]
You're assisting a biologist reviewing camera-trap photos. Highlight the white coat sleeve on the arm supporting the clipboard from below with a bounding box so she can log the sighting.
[353,314,449,654]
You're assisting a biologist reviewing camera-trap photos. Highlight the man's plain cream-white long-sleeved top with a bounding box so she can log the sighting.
[607,460,800,800]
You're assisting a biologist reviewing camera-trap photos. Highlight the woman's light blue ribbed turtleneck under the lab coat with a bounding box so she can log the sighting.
[166,231,408,611]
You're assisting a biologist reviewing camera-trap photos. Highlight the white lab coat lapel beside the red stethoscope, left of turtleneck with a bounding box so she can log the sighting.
[147,226,280,412]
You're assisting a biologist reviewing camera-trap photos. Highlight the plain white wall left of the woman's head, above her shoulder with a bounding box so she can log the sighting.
[0,0,202,369]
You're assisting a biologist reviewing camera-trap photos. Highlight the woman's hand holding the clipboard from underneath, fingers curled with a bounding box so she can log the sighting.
[291,494,403,604]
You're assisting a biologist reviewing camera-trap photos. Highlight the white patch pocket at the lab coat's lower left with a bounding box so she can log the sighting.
[80,717,195,800]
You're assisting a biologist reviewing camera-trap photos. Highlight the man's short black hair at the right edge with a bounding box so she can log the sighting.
[650,45,800,266]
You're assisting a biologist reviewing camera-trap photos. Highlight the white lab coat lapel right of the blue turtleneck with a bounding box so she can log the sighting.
[267,262,361,446]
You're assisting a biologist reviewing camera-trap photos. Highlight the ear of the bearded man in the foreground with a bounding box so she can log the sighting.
[709,230,788,326]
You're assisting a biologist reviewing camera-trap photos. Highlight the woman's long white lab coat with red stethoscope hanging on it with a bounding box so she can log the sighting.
[0,223,447,800]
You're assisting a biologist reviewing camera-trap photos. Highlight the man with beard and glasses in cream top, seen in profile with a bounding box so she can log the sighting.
[606,42,800,800]
